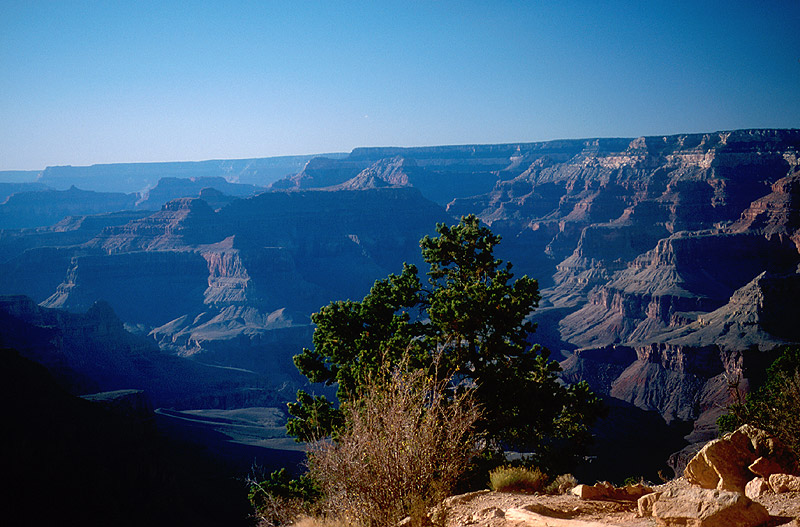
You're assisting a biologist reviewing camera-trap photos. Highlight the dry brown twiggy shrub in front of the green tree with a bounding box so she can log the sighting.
[309,370,479,526]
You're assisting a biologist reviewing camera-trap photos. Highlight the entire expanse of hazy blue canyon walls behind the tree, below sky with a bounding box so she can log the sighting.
[0,130,800,482]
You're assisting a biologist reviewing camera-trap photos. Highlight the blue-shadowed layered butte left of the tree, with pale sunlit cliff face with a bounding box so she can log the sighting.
[28,187,447,383]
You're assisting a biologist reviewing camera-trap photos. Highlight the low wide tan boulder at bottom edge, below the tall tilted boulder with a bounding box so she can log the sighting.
[653,487,769,527]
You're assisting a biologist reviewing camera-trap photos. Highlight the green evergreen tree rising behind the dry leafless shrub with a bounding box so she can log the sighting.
[287,215,602,466]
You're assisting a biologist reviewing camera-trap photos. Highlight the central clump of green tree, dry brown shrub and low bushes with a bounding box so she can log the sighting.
[251,215,604,527]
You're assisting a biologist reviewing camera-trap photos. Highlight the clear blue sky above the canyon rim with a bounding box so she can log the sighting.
[0,0,800,170]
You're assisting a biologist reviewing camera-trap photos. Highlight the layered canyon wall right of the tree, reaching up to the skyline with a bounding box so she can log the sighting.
[268,130,800,456]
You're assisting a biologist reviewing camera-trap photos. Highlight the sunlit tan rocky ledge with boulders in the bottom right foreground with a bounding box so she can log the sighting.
[437,425,800,527]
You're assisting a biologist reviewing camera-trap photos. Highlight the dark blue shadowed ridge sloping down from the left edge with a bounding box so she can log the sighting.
[0,296,290,408]
